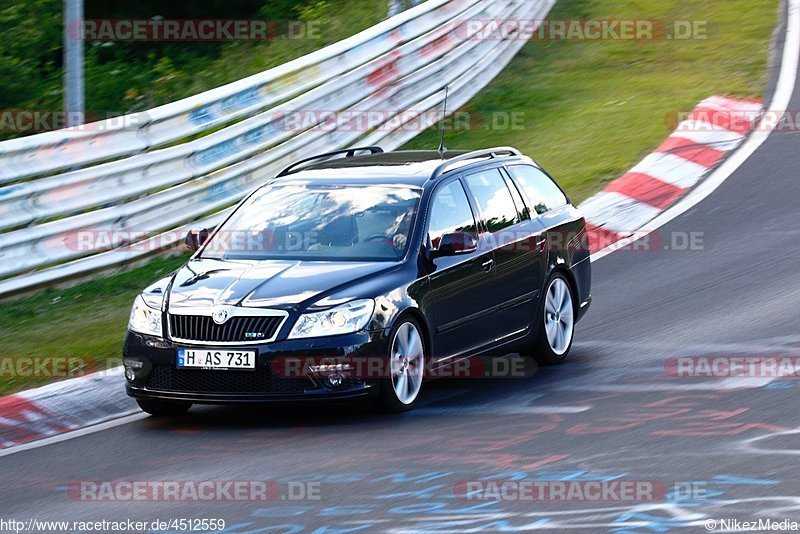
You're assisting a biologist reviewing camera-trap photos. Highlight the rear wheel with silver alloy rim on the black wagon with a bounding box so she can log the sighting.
[527,272,576,365]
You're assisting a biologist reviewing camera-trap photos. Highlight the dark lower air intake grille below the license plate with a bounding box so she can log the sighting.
[146,365,316,394]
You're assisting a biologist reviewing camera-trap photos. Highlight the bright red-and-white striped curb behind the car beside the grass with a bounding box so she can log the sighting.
[580,96,763,252]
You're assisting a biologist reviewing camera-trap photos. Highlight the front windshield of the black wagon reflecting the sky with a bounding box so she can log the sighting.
[202,185,420,261]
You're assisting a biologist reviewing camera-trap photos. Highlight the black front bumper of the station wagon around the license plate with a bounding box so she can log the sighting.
[123,330,388,404]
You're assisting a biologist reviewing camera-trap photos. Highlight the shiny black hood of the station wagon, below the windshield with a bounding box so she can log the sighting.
[169,259,397,309]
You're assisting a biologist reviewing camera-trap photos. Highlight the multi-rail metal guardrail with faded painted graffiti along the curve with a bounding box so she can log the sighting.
[0,0,555,295]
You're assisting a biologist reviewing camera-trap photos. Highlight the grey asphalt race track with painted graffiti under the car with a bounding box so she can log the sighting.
[0,7,800,532]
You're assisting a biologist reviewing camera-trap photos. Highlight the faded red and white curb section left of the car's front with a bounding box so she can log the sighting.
[0,367,134,451]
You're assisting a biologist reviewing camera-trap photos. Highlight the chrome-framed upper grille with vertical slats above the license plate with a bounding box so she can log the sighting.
[169,314,283,343]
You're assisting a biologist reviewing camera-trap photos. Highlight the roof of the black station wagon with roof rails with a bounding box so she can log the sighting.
[273,150,527,187]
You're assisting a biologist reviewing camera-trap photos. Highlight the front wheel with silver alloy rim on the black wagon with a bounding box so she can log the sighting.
[379,318,426,413]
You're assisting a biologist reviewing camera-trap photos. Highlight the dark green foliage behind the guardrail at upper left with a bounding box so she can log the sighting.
[0,0,386,139]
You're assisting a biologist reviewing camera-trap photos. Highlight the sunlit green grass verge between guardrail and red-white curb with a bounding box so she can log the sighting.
[408,0,778,202]
